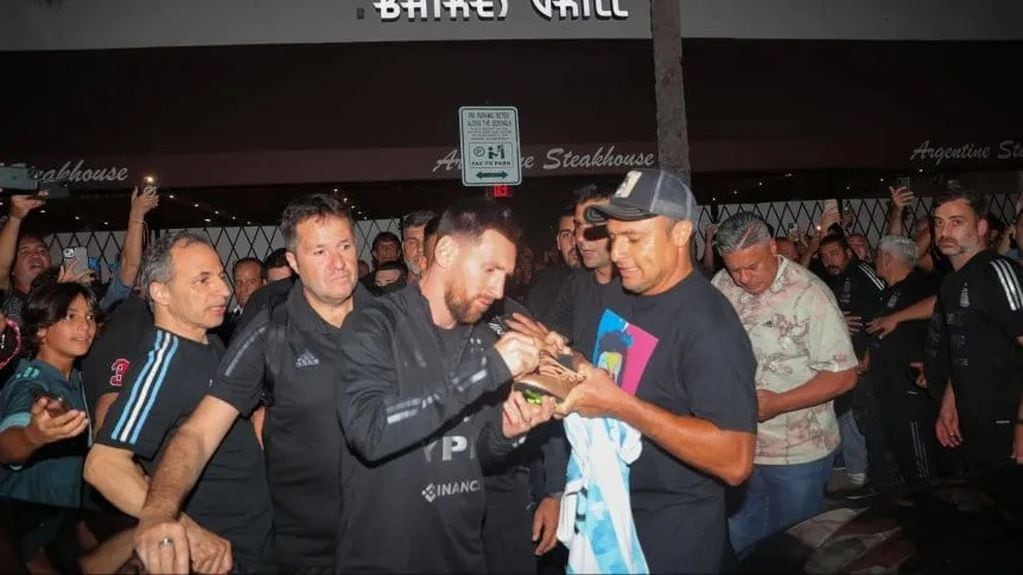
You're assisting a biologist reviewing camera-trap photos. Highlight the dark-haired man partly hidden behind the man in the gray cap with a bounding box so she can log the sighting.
[548,184,632,358]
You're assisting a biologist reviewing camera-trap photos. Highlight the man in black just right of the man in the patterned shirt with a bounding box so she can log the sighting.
[819,234,885,486]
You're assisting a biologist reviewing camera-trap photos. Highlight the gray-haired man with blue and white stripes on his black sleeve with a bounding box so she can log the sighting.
[84,232,273,573]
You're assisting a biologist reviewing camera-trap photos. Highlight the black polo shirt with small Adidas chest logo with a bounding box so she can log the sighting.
[210,281,371,567]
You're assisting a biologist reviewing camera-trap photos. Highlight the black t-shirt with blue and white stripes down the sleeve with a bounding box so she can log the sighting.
[96,328,273,572]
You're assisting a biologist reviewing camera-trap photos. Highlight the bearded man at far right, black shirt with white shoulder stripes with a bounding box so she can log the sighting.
[934,189,1023,472]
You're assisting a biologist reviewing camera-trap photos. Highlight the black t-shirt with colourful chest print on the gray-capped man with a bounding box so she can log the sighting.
[625,272,757,572]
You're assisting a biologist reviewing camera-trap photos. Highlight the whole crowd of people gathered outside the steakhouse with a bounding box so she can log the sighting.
[0,170,1023,574]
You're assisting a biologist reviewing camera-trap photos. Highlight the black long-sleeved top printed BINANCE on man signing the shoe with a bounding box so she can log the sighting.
[336,285,518,573]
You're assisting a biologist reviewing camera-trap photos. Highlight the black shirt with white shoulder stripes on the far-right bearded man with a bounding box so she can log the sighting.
[939,251,1023,469]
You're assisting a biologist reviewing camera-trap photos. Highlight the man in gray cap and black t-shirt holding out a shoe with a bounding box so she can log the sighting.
[559,170,757,573]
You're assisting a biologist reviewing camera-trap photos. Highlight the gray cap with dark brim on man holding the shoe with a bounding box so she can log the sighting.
[586,170,697,224]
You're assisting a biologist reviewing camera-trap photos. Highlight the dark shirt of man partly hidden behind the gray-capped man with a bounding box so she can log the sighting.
[548,268,635,357]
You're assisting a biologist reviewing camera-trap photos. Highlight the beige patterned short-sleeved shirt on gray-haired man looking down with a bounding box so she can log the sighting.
[713,256,857,466]
